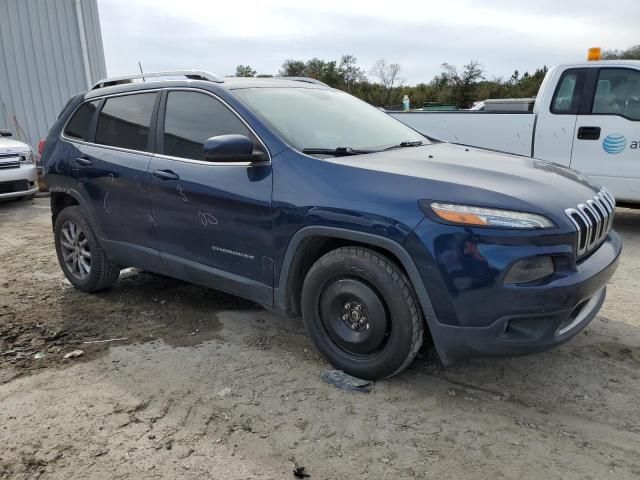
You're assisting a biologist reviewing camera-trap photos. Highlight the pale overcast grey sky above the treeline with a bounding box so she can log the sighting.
[98,0,640,84]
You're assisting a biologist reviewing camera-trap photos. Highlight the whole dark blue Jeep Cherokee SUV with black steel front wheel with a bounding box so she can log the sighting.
[43,71,621,379]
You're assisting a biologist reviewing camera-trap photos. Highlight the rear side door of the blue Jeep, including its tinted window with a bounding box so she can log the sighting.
[69,92,159,269]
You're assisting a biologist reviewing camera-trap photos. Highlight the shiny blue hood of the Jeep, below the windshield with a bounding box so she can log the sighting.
[333,143,599,216]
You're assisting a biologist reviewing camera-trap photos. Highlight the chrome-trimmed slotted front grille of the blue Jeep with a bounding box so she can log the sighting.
[565,187,616,257]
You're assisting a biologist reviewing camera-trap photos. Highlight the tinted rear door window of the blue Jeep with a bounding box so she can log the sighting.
[96,92,158,151]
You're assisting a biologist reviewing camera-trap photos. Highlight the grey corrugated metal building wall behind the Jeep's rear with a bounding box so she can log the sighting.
[0,0,106,147]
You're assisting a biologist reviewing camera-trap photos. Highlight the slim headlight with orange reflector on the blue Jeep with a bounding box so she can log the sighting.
[420,202,555,229]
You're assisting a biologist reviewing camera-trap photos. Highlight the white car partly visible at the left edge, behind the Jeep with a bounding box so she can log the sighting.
[0,130,38,200]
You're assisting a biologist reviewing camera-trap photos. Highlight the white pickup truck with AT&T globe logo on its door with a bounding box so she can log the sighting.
[389,60,640,204]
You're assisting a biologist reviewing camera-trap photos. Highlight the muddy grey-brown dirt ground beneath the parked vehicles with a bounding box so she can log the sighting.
[0,198,640,480]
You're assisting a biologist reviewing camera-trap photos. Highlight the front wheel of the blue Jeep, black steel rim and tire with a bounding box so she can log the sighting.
[301,247,424,380]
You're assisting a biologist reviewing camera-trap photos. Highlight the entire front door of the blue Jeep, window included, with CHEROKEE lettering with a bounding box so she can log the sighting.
[149,90,273,304]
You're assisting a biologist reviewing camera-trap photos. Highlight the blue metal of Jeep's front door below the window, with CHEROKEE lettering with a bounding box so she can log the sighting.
[150,156,273,286]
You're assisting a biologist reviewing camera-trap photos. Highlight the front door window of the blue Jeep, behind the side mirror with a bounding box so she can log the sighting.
[163,92,253,160]
